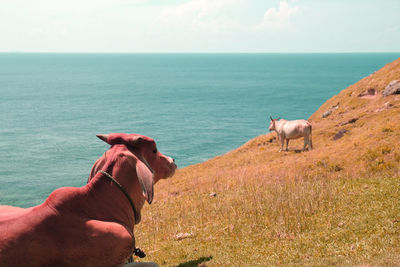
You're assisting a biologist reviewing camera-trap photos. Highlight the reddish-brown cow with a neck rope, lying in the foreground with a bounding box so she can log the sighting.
[0,134,176,266]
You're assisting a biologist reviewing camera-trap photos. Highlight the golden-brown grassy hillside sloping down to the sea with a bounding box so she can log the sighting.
[135,59,400,266]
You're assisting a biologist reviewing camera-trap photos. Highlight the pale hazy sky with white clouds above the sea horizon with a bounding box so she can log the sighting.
[0,0,400,53]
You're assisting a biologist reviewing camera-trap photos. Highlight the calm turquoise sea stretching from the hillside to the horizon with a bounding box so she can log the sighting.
[0,53,400,207]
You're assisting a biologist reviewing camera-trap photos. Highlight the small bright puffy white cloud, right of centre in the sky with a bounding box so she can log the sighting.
[257,1,299,30]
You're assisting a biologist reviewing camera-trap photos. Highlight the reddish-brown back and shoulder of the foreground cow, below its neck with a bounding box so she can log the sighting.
[0,188,134,267]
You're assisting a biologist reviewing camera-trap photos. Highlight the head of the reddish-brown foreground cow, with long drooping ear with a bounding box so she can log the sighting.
[92,133,177,203]
